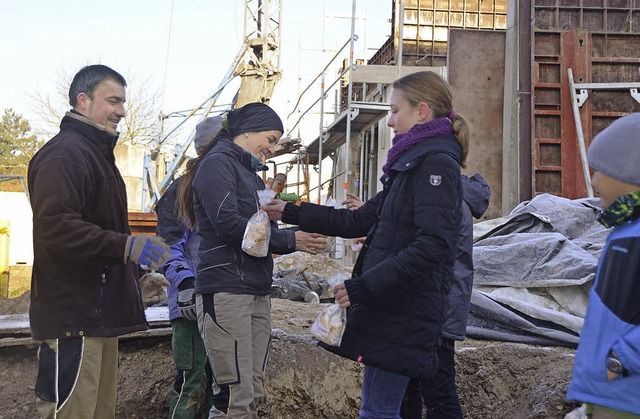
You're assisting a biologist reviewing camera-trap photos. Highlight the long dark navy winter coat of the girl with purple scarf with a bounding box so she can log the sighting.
[282,134,462,378]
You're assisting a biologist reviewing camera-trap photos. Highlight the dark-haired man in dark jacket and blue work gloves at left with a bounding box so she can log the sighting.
[28,65,169,419]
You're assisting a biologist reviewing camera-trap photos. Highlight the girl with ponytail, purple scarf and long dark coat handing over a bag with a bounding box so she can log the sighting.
[264,71,468,418]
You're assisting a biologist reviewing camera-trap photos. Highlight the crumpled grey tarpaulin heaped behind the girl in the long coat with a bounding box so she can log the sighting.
[467,194,608,346]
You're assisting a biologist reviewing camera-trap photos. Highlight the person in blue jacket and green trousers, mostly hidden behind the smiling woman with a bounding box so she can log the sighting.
[156,116,229,419]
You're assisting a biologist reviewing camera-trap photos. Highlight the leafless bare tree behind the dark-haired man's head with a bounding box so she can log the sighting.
[29,71,160,146]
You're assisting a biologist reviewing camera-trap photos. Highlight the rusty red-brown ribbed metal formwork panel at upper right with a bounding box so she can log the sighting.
[521,0,640,198]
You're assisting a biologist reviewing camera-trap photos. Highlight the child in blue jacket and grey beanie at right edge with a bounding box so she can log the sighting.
[567,113,640,419]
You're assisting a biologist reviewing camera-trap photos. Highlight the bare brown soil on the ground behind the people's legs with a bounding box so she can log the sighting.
[0,297,576,419]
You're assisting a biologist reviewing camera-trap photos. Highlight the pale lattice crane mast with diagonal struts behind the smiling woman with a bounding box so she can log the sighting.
[142,0,295,211]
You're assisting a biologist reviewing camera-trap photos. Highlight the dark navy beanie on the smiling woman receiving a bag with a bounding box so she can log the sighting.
[226,102,284,138]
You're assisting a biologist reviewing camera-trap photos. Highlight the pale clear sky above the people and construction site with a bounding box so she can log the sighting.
[0,0,392,144]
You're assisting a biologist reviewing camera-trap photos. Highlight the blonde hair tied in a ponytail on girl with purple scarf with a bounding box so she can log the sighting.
[393,71,469,167]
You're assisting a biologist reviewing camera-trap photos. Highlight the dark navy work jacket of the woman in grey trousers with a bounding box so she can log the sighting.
[193,138,296,295]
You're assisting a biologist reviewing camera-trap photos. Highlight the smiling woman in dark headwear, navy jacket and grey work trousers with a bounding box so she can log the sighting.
[178,103,325,418]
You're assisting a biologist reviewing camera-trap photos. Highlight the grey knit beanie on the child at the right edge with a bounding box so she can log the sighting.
[588,112,640,186]
